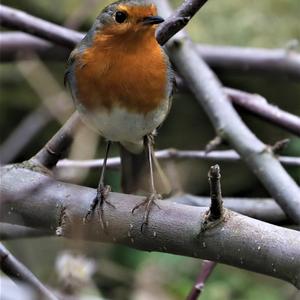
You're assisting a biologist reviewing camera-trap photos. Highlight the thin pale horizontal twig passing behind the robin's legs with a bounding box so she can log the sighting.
[57,149,300,169]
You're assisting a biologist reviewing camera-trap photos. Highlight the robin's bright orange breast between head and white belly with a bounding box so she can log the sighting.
[75,28,168,114]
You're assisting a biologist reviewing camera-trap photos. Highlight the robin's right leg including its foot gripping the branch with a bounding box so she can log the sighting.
[132,134,162,231]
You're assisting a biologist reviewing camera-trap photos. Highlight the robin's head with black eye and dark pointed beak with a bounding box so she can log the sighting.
[97,0,164,36]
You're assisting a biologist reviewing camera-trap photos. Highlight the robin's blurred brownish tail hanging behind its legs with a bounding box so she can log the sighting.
[120,145,171,195]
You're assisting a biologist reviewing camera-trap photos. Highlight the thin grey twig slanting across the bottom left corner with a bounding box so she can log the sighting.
[0,243,57,300]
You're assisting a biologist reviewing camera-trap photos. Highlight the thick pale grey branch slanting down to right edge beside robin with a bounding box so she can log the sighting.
[159,0,300,224]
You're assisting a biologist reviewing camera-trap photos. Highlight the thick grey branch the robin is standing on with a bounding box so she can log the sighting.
[1,166,300,287]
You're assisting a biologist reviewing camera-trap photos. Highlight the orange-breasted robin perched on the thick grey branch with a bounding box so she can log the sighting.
[65,0,174,228]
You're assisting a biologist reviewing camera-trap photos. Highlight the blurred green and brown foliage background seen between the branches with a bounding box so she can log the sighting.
[0,0,300,300]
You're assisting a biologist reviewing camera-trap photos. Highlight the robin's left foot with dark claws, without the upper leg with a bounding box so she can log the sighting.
[83,184,115,229]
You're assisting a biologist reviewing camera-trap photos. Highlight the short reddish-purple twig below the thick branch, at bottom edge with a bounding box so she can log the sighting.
[186,260,217,300]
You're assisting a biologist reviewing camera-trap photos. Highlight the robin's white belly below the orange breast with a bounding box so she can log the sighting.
[76,99,170,143]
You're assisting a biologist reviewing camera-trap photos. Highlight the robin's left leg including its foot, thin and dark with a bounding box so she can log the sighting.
[84,141,114,228]
